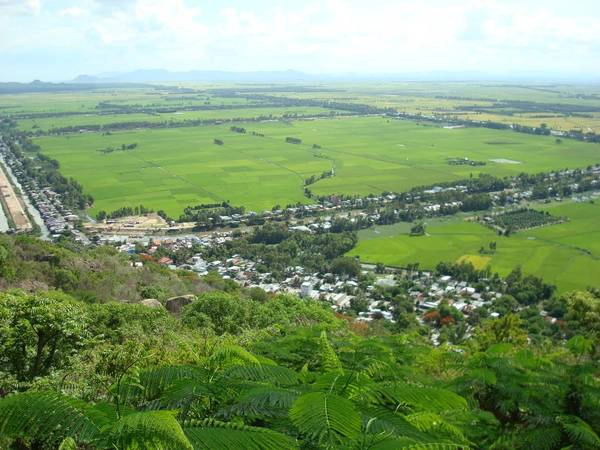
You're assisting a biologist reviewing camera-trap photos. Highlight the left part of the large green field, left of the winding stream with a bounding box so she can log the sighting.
[37,126,331,217]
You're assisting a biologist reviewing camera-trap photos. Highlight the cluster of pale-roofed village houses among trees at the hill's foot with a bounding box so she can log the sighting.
[110,232,524,338]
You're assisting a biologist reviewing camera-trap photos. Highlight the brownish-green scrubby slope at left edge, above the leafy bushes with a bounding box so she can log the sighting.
[0,235,209,302]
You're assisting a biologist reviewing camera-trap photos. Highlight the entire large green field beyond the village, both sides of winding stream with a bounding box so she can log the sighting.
[35,117,600,216]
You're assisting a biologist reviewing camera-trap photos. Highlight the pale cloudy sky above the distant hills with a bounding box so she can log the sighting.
[0,0,600,81]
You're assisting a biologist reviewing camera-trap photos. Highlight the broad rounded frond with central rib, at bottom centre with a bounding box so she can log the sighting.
[290,392,361,444]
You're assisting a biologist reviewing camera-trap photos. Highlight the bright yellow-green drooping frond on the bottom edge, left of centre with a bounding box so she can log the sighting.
[102,411,193,450]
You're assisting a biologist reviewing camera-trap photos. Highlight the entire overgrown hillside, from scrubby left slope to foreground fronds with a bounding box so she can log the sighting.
[0,234,600,450]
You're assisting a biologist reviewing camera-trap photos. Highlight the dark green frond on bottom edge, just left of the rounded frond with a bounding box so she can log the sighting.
[184,419,298,450]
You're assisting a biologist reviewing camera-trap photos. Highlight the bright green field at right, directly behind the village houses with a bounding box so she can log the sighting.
[349,202,600,291]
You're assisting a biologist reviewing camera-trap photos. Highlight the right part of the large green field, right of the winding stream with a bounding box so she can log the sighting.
[264,117,600,195]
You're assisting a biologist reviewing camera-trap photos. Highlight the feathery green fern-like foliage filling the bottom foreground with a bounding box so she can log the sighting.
[0,320,600,449]
